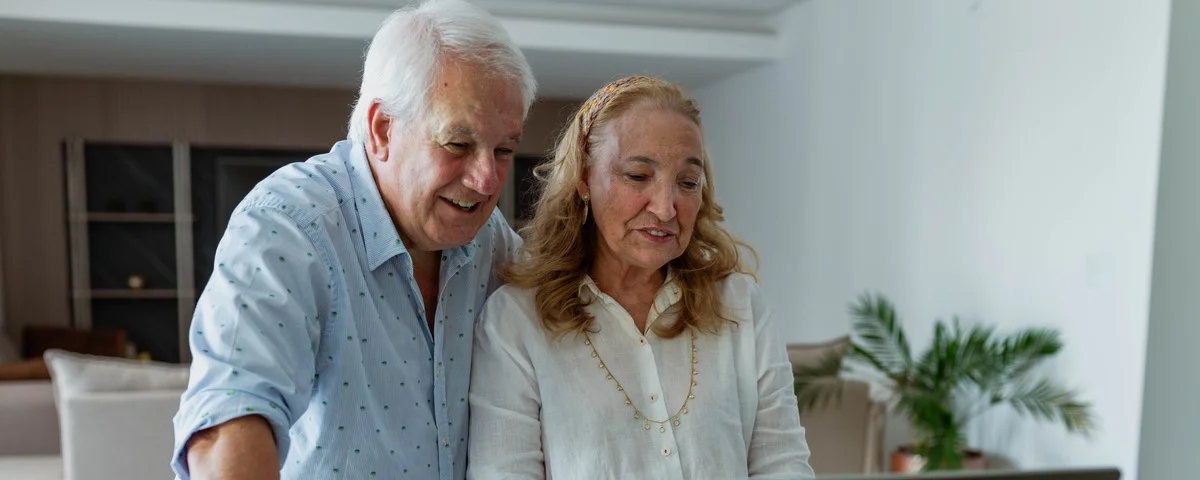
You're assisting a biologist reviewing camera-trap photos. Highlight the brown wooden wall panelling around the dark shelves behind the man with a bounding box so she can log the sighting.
[0,76,577,335]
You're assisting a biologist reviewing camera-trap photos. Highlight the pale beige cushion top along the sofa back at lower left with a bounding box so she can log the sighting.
[44,349,188,402]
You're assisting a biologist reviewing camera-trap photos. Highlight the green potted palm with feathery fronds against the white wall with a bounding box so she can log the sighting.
[796,294,1093,470]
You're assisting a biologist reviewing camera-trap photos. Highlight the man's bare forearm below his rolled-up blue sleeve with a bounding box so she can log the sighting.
[187,415,280,480]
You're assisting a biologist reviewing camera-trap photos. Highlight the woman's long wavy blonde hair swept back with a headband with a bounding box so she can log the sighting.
[504,77,754,338]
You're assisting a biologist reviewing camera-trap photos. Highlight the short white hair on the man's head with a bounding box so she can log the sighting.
[349,0,538,143]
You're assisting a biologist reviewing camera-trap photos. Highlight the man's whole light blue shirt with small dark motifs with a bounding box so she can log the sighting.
[172,142,520,480]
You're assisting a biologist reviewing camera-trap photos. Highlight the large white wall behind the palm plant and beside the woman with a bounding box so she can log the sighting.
[696,0,1169,478]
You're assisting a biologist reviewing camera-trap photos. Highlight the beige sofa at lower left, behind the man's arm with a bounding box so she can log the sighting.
[0,354,186,480]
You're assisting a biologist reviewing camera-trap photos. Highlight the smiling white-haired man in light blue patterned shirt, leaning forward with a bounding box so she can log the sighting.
[172,0,535,479]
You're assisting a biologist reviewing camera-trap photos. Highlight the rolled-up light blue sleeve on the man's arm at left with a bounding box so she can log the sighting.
[172,206,332,479]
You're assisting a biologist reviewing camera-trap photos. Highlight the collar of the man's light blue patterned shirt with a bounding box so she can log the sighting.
[335,140,479,271]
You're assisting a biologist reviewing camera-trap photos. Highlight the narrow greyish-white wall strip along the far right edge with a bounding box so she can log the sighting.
[1139,1,1200,480]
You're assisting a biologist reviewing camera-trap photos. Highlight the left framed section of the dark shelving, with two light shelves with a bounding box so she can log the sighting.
[66,139,196,361]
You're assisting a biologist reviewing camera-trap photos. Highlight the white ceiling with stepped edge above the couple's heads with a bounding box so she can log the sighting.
[0,0,790,97]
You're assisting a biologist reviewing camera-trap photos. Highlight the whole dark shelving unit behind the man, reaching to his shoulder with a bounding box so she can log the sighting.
[64,139,313,362]
